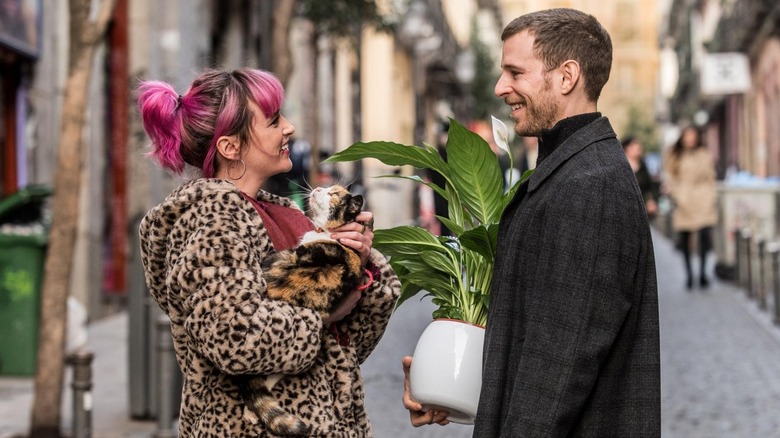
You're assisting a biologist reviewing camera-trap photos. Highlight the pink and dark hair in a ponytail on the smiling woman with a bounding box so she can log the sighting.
[138,68,284,178]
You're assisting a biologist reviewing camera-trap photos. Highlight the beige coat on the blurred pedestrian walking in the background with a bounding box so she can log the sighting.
[664,147,718,231]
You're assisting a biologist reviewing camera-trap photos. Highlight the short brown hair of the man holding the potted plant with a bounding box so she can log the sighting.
[501,8,612,102]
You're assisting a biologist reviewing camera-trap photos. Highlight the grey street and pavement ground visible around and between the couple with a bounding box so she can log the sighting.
[0,228,780,438]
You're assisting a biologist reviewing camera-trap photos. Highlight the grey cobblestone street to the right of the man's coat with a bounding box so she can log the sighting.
[655,228,780,438]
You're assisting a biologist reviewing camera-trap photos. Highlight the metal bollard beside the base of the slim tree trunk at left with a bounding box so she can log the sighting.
[67,349,95,438]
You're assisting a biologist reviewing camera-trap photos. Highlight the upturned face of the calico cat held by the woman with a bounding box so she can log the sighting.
[308,185,363,230]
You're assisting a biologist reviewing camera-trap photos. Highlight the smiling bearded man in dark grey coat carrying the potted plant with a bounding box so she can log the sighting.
[405,9,661,438]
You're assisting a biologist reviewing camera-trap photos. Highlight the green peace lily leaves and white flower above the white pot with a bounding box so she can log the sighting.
[326,117,530,326]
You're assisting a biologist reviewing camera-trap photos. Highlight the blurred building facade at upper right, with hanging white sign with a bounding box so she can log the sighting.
[665,0,780,179]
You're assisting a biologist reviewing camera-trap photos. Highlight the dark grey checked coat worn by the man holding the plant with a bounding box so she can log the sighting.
[474,117,661,438]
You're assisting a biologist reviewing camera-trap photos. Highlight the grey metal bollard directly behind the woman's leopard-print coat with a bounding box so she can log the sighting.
[153,315,176,438]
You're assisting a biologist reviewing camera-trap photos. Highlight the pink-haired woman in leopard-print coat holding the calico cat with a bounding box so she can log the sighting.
[138,68,400,437]
